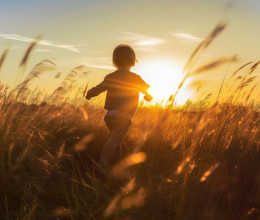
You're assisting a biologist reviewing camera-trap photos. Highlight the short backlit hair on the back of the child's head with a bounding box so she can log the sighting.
[113,44,136,68]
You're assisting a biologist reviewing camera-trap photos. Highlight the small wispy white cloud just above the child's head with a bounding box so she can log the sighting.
[120,32,167,46]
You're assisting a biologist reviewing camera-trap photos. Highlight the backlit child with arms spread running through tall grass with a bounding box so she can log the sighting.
[86,44,152,172]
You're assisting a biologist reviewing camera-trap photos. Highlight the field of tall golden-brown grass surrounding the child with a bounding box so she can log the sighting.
[0,23,260,220]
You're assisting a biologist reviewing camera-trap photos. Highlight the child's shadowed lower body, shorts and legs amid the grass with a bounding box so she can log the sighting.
[99,115,131,168]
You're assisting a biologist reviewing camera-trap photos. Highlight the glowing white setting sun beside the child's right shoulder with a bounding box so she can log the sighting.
[134,60,191,105]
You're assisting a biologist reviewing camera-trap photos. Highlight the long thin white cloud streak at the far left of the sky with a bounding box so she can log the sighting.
[0,33,87,53]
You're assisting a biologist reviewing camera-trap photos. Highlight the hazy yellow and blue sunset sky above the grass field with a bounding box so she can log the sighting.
[0,0,260,104]
